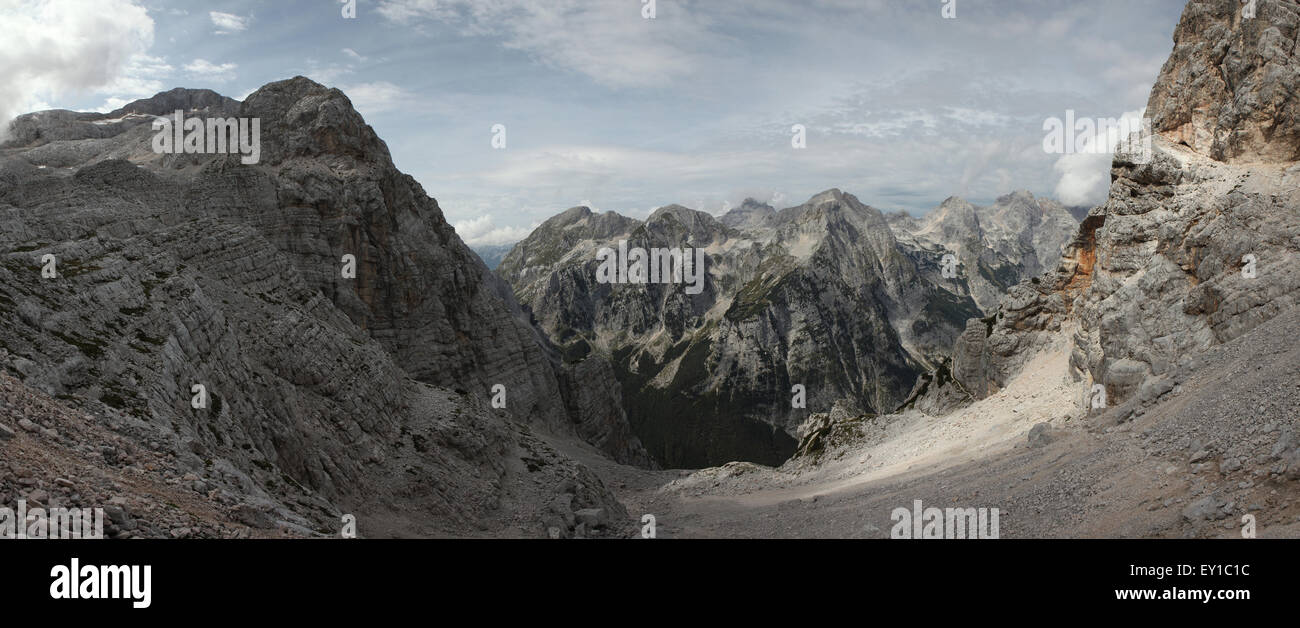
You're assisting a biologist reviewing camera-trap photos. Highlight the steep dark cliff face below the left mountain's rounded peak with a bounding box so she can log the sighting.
[185,79,569,429]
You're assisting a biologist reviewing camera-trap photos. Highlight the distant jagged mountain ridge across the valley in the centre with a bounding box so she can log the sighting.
[497,190,1075,467]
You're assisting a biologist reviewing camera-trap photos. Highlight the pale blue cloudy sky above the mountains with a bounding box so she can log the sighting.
[0,0,1184,246]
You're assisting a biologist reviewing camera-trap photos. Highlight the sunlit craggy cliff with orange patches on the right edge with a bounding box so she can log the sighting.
[954,0,1300,413]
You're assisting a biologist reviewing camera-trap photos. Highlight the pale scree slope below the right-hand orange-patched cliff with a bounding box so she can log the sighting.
[571,309,1300,538]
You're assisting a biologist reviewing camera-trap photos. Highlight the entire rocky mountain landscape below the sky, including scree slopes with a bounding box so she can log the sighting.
[0,0,1300,538]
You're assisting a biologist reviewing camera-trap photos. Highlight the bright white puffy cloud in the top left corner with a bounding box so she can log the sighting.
[0,0,153,135]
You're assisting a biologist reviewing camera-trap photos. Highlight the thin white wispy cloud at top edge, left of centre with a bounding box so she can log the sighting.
[377,0,728,87]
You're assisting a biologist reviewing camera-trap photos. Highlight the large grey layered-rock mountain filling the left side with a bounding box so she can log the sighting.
[0,78,650,536]
